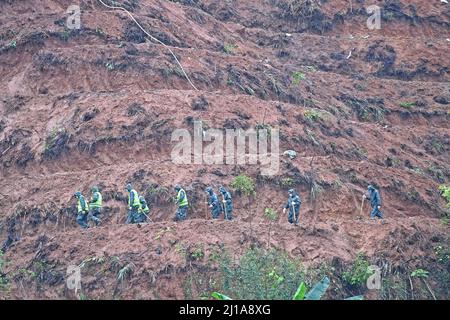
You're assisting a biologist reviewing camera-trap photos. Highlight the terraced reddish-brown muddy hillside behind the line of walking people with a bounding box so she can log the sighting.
[0,0,450,299]
